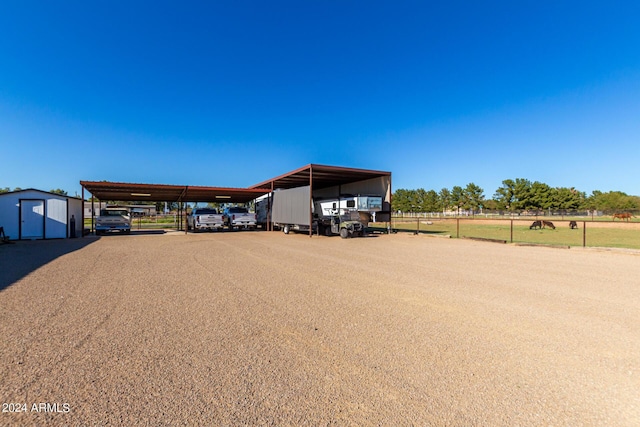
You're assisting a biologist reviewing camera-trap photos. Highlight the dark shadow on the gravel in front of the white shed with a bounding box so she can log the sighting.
[0,237,98,292]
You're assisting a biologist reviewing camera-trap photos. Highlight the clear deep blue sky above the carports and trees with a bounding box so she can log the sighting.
[0,0,640,198]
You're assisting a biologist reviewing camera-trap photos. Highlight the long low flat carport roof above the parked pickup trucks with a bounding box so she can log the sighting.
[80,181,268,203]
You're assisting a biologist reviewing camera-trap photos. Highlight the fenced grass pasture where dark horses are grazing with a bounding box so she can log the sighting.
[370,218,640,249]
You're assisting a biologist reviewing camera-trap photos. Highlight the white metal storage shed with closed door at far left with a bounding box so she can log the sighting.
[0,189,83,240]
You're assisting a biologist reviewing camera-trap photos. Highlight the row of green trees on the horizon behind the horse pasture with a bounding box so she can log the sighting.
[391,178,640,213]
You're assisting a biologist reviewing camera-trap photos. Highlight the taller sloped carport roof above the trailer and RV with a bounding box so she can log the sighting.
[249,164,391,190]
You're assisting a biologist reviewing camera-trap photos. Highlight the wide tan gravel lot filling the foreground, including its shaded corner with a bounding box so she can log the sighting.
[0,232,640,426]
